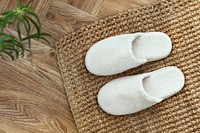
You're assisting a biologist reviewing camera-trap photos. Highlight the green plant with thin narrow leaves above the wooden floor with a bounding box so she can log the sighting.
[0,0,50,60]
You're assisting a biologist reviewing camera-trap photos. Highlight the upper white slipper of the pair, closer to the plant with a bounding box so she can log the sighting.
[85,32,172,76]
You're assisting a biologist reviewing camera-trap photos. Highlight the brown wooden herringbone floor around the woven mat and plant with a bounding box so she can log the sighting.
[0,0,159,133]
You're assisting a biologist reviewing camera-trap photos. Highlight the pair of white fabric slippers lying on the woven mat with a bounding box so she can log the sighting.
[85,32,185,115]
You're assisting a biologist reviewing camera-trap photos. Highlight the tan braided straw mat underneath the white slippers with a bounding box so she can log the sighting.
[56,0,200,133]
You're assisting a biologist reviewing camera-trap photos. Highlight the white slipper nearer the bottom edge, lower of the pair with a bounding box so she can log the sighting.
[98,66,185,115]
